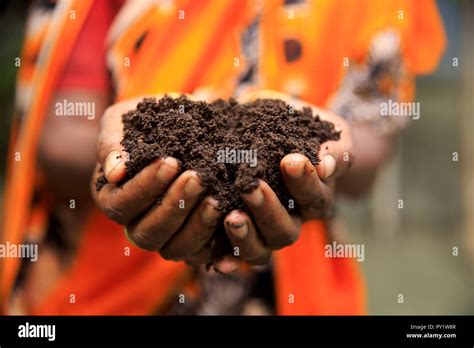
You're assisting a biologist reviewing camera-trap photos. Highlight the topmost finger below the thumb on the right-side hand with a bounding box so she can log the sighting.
[280,153,333,212]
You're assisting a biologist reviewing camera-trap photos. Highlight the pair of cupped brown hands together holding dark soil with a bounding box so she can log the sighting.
[92,91,352,273]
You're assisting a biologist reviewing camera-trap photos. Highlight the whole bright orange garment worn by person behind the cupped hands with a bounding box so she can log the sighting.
[1,0,445,314]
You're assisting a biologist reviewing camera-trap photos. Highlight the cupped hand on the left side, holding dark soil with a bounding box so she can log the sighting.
[91,96,238,273]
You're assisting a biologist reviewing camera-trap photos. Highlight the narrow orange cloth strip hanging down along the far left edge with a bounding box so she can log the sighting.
[0,1,96,312]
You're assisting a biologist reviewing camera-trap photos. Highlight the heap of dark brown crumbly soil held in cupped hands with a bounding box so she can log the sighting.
[96,96,339,259]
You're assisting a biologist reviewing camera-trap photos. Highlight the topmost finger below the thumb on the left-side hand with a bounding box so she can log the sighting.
[92,157,179,225]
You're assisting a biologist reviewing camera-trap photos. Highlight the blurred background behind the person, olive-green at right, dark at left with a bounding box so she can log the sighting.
[0,1,474,314]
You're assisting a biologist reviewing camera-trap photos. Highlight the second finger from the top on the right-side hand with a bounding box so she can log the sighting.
[241,180,300,249]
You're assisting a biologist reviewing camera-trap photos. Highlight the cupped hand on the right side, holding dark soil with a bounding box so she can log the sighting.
[206,91,353,273]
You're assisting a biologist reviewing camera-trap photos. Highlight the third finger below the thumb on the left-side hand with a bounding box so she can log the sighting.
[160,197,222,259]
